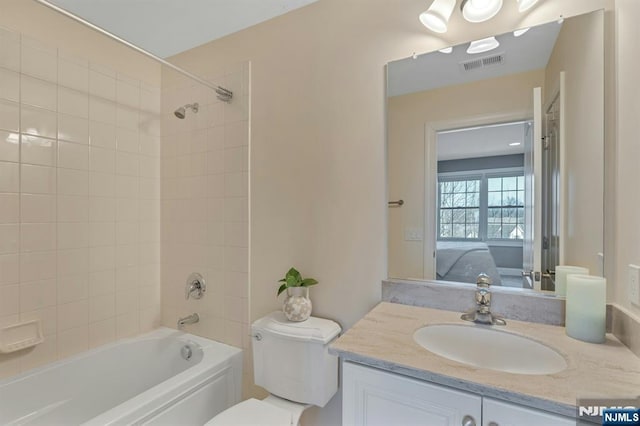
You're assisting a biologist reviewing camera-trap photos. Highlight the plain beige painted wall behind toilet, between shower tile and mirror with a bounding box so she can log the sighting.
[172,0,612,424]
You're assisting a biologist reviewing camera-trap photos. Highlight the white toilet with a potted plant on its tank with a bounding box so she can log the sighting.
[207,311,341,426]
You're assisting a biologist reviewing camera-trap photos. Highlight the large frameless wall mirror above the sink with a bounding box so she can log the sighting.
[387,11,604,291]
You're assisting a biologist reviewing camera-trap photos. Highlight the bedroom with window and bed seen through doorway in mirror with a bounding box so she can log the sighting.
[435,121,533,287]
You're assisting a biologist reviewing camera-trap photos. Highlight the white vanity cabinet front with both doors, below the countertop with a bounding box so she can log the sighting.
[342,362,576,426]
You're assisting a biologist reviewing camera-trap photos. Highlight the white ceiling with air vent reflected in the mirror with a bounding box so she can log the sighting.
[387,22,562,96]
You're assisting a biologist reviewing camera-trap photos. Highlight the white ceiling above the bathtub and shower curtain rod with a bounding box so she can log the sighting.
[49,0,317,58]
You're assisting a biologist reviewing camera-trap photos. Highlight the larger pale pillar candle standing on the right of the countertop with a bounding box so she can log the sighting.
[565,275,607,343]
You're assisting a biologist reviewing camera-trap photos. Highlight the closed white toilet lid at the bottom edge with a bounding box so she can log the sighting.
[206,398,291,426]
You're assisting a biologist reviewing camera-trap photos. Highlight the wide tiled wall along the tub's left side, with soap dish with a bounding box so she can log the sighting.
[0,30,160,377]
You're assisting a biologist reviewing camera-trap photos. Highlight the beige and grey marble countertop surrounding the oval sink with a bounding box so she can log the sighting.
[330,302,640,417]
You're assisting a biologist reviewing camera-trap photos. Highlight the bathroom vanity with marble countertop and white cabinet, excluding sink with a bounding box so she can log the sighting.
[331,302,640,426]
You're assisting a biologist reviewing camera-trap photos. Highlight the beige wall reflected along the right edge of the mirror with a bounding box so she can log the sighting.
[543,13,605,275]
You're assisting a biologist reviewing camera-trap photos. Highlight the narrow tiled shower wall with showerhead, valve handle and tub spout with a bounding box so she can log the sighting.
[161,63,253,390]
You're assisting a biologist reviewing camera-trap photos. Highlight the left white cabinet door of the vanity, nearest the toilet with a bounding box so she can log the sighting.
[342,362,482,426]
